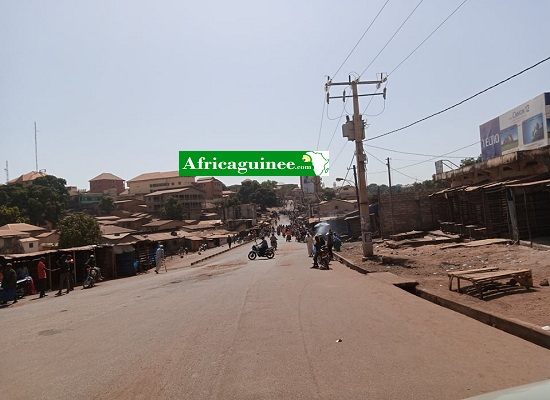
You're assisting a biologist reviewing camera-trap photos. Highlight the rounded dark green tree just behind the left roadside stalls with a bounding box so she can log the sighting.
[57,213,101,248]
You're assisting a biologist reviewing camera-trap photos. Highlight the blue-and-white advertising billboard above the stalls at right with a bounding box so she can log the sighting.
[479,93,550,160]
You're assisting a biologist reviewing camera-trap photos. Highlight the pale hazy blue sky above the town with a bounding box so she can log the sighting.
[0,0,550,189]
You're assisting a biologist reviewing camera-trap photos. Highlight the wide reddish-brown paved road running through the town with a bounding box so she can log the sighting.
[0,242,550,400]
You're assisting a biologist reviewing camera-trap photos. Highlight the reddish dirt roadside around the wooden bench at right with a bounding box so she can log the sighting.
[337,236,550,328]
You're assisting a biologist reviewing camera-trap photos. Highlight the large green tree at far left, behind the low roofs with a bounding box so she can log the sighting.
[0,175,69,226]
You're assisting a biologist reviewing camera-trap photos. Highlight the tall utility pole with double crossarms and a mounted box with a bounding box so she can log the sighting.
[325,77,387,257]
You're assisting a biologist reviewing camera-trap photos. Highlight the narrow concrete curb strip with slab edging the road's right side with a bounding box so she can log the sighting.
[334,253,550,349]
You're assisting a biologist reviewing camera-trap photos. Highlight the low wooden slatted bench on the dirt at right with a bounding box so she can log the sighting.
[448,267,533,299]
